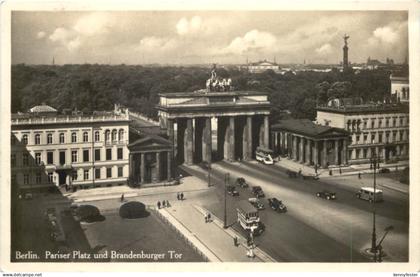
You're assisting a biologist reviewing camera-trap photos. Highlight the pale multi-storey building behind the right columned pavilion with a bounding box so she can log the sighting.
[316,101,409,164]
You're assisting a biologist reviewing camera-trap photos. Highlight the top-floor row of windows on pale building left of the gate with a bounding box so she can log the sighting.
[11,129,124,145]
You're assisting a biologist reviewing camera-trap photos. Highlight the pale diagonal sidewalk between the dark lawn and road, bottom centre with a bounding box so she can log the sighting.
[158,203,268,262]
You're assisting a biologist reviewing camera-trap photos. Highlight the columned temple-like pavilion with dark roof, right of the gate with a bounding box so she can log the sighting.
[271,119,350,168]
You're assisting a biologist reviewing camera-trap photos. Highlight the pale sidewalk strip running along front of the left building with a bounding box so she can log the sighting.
[63,176,210,202]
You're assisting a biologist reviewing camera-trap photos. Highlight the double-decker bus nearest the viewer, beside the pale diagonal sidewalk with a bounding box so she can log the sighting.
[236,200,264,234]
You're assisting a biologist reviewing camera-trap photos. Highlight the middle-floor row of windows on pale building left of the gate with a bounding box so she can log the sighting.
[10,148,124,167]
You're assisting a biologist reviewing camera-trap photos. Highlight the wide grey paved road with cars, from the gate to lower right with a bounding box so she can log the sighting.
[182,162,408,262]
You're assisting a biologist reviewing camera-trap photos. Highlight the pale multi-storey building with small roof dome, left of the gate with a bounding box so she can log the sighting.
[11,105,129,189]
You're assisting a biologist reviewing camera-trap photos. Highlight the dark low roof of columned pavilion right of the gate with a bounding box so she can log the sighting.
[271,119,349,138]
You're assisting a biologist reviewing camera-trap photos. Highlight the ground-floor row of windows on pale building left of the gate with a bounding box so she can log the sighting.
[12,166,124,185]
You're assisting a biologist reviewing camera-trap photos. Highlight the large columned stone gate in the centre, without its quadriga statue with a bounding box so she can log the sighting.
[157,90,271,164]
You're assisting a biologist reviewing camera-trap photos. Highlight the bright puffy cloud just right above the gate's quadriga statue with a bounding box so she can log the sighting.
[221,30,278,54]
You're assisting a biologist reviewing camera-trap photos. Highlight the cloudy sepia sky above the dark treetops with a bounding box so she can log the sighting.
[12,11,408,64]
